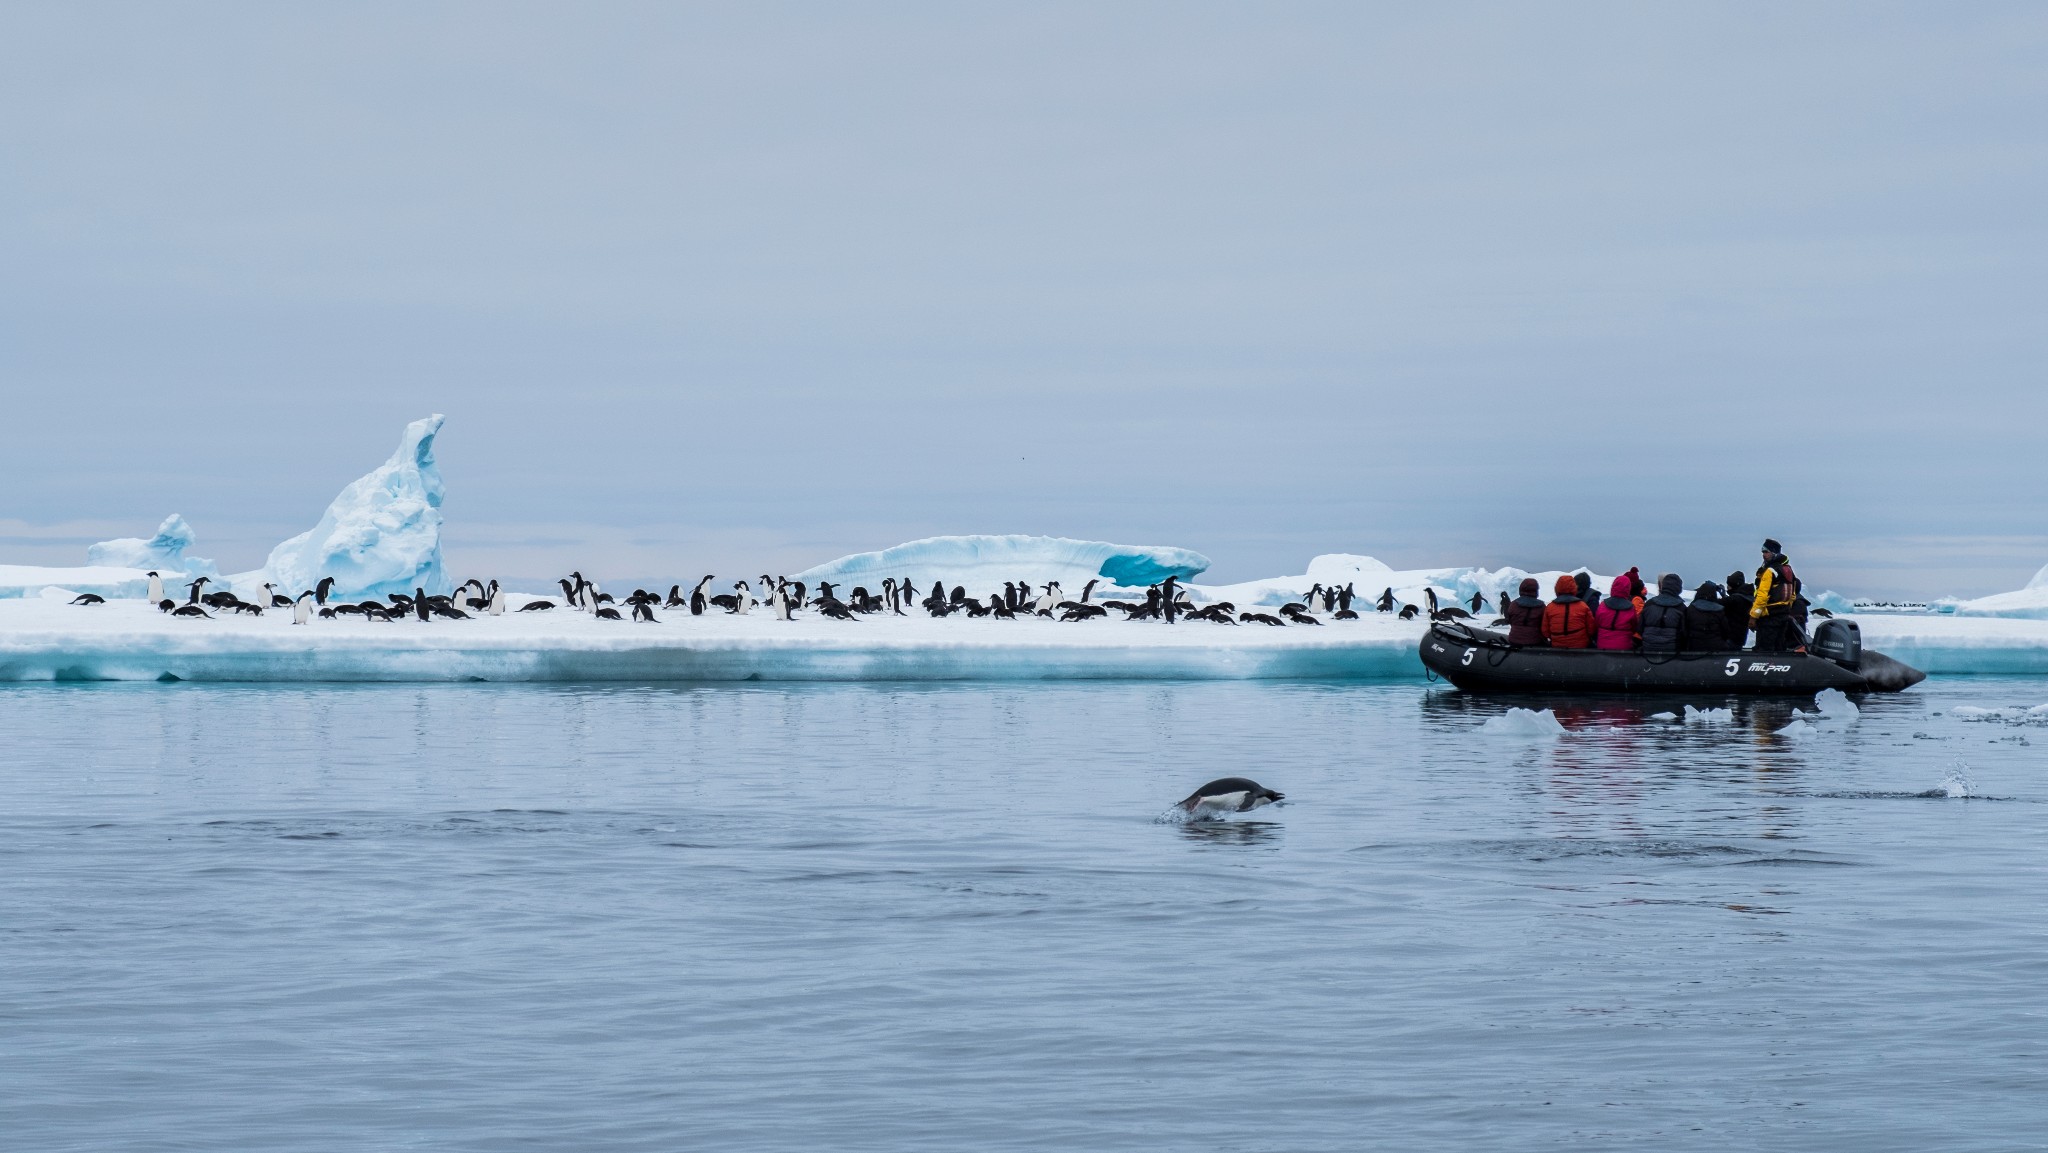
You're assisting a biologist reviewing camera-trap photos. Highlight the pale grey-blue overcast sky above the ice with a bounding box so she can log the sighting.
[0,2,2048,596]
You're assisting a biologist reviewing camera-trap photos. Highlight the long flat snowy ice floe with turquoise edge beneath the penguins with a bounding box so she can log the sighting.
[0,598,2048,682]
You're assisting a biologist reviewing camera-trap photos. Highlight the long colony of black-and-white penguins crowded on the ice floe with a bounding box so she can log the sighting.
[72,571,1485,629]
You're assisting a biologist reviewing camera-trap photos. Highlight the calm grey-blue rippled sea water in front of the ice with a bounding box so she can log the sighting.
[0,680,2048,1151]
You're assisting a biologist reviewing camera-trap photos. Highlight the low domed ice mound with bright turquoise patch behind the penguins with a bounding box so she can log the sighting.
[795,537,1208,598]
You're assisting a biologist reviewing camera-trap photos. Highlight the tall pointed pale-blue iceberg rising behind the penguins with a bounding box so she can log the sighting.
[253,414,453,598]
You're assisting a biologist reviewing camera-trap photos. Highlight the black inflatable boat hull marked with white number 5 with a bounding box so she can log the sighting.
[1421,621,1927,696]
